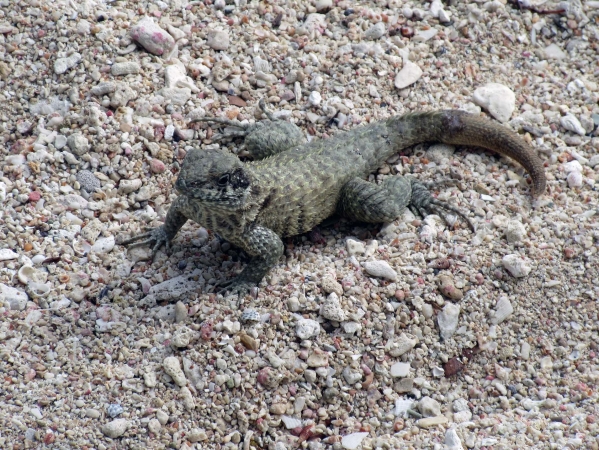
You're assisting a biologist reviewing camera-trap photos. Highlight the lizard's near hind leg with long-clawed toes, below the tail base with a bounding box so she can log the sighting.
[338,176,474,229]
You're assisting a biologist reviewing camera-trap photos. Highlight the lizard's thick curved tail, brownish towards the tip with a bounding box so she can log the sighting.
[388,110,547,197]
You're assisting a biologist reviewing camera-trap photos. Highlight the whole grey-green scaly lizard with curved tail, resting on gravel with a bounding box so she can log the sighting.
[122,101,546,295]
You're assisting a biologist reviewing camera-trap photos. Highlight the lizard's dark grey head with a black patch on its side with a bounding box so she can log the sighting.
[175,149,250,208]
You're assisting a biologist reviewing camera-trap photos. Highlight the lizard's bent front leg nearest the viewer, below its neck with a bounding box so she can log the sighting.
[219,226,284,295]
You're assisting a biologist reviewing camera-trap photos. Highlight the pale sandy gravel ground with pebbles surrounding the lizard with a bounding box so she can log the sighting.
[0,0,599,450]
